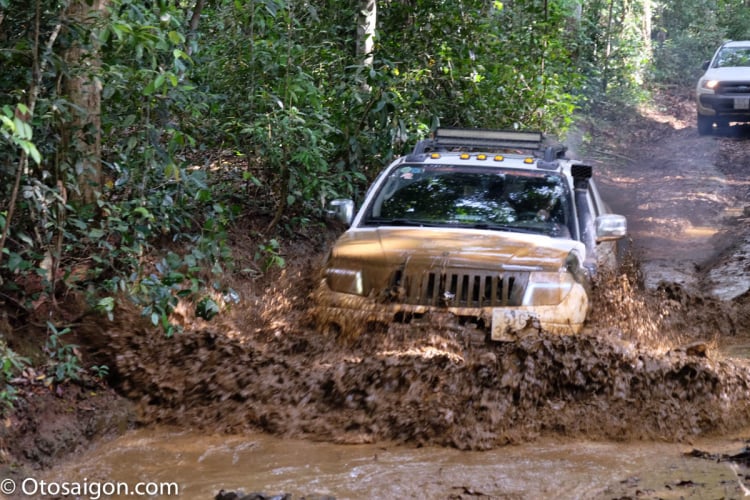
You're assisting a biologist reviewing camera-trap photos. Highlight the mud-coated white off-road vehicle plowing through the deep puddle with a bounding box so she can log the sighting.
[314,129,626,341]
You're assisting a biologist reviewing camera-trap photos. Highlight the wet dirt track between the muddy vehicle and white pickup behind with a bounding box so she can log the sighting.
[590,92,750,299]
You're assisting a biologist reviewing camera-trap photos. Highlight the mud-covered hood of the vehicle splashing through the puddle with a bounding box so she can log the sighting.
[332,228,586,271]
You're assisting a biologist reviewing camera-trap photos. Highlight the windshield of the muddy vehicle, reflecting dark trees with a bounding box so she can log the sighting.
[361,165,573,238]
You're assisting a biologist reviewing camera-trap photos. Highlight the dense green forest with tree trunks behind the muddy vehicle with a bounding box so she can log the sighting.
[0,0,750,410]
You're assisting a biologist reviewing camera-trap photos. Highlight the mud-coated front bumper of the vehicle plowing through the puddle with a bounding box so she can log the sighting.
[314,280,589,341]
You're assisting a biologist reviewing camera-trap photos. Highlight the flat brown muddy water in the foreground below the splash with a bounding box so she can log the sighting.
[47,428,744,499]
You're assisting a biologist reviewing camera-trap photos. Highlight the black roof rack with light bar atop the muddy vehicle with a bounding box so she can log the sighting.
[412,128,565,161]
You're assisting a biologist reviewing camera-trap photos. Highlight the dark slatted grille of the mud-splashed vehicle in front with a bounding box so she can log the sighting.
[389,270,529,307]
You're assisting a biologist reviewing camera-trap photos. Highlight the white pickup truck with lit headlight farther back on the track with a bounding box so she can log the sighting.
[696,40,750,135]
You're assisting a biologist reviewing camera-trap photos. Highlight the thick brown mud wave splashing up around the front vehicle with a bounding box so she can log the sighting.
[81,258,750,450]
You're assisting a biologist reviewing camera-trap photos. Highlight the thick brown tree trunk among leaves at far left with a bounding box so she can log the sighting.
[63,0,108,204]
